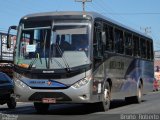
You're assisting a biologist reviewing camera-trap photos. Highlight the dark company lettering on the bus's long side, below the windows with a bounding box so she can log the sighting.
[109,61,124,69]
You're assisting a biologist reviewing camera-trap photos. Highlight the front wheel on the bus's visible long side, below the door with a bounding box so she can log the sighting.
[100,82,111,111]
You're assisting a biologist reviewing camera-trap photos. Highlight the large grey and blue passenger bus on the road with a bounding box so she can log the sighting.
[8,12,154,112]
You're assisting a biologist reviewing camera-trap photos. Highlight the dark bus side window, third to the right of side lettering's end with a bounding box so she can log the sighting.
[140,38,147,58]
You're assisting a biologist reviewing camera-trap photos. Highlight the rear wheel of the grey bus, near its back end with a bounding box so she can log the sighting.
[134,83,142,103]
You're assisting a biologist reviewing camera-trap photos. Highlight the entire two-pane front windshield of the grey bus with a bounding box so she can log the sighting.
[16,25,90,69]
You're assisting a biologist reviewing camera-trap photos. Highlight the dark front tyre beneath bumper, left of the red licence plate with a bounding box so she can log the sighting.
[34,102,49,114]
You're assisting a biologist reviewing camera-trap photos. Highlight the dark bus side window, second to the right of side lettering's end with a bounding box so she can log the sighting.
[133,36,140,57]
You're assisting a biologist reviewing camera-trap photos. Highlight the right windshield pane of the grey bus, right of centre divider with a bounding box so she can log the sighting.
[50,25,89,68]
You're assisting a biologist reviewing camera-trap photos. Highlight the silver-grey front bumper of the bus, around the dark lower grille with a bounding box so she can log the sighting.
[14,81,92,103]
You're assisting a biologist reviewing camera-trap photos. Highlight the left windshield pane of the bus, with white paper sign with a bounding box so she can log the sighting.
[17,27,51,68]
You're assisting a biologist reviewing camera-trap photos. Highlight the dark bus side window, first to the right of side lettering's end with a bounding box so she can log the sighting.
[125,33,133,56]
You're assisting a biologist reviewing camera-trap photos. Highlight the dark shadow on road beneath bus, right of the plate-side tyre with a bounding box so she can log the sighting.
[42,100,145,115]
